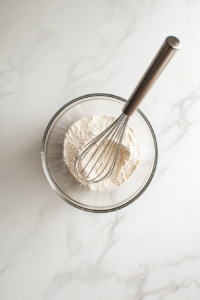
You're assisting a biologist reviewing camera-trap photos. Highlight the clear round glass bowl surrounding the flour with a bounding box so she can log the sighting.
[41,94,158,212]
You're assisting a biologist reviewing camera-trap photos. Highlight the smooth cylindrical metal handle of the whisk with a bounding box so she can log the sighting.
[122,36,181,116]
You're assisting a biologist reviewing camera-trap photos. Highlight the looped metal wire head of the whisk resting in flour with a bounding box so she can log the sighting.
[74,113,129,183]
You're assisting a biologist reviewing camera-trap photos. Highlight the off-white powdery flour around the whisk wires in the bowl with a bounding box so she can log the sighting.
[64,116,140,190]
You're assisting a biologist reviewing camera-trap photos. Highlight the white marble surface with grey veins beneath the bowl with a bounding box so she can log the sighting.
[0,0,200,300]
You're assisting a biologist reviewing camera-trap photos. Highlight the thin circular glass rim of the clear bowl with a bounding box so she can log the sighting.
[41,93,158,213]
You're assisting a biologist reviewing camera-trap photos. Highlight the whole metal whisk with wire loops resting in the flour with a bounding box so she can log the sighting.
[74,36,181,184]
